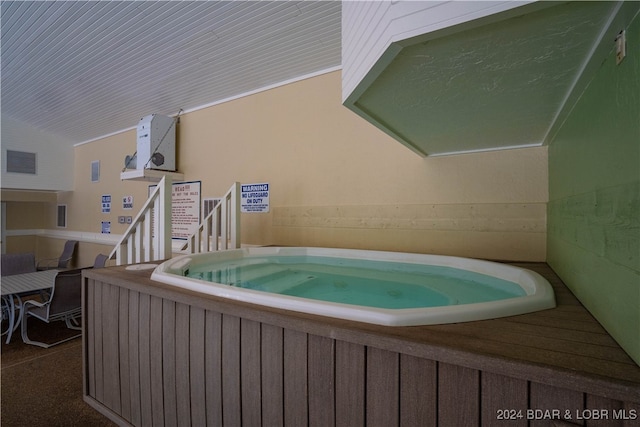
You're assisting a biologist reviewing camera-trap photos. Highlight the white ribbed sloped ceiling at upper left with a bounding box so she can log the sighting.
[1,1,341,143]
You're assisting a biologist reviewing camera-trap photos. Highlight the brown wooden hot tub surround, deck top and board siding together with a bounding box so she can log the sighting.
[83,263,640,427]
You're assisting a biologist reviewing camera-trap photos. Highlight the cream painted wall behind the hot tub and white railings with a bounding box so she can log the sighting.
[72,72,548,261]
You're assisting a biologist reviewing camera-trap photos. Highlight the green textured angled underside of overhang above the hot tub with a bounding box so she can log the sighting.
[345,1,635,156]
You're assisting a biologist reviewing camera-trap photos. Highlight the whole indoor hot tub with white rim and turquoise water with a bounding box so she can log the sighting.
[151,247,555,326]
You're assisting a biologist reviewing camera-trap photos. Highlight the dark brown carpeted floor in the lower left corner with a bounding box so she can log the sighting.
[0,319,115,427]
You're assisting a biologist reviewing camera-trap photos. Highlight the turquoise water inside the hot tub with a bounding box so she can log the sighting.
[186,256,525,309]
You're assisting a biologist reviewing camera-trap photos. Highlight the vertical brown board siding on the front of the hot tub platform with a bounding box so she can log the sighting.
[84,282,640,427]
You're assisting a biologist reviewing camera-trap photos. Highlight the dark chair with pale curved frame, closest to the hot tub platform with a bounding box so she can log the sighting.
[21,269,82,348]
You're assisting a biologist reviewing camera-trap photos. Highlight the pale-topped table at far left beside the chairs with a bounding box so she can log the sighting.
[0,270,60,344]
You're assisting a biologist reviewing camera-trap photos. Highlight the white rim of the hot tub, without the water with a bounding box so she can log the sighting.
[151,247,555,326]
